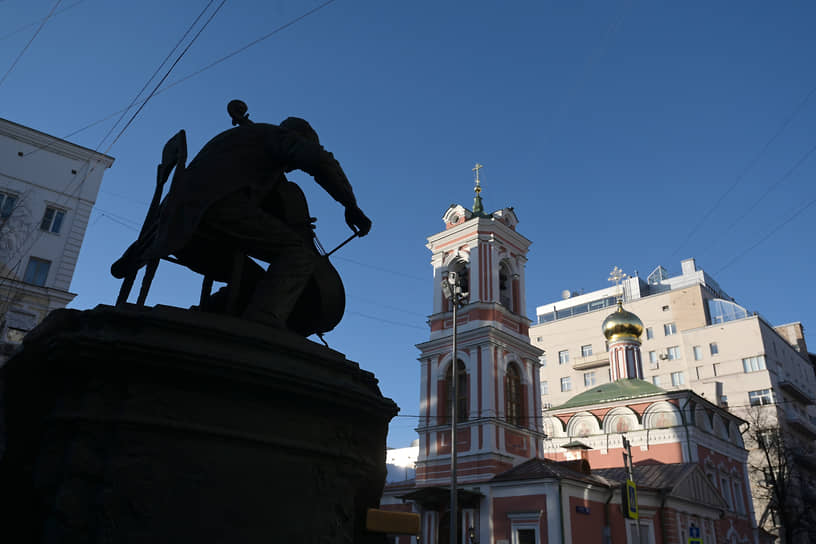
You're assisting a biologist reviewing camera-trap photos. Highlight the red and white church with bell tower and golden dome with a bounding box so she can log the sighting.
[381,173,762,544]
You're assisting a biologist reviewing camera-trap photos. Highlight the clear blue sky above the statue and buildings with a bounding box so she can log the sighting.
[0,0,816,446]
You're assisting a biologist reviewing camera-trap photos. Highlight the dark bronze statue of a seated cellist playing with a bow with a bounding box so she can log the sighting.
[111,100,371,336]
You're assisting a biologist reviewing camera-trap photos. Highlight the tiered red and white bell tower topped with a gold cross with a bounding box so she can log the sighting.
[416,168,543,486]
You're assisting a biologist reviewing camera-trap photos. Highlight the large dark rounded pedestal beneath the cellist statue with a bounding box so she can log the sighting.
[0,306,398,544]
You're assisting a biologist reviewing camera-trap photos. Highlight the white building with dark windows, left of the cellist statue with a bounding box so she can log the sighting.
[0,119,114,363]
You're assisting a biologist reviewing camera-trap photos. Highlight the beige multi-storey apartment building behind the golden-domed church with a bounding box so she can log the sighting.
[530,259,816,528]
